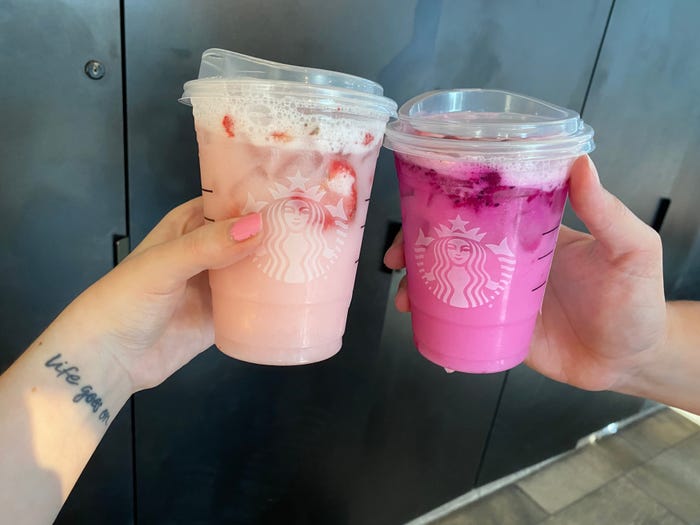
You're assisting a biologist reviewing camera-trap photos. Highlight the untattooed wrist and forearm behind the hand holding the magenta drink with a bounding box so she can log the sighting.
[619,301,700,414]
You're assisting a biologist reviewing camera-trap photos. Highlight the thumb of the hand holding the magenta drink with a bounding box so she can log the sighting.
[569,155,655,257]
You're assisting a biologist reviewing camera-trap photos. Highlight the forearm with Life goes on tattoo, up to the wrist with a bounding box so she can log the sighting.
[0,313,131,524]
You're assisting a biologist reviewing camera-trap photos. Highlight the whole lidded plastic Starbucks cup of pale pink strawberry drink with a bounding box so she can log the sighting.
[181,49,396,365]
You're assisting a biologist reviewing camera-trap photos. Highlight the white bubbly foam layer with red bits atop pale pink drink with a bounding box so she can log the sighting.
[192,92,386,153]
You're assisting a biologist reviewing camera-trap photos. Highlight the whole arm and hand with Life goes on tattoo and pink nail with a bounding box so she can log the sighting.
[0,198,261,523]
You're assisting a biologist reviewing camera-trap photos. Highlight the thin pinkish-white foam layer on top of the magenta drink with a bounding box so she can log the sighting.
[400,154,575,191]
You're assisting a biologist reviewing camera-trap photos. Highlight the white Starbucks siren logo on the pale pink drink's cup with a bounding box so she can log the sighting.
[243,171,348,283]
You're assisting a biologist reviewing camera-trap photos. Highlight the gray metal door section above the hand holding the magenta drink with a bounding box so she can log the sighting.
[560,0,700,299]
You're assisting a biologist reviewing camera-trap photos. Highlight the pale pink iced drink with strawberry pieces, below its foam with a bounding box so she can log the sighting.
[195,117,382,364]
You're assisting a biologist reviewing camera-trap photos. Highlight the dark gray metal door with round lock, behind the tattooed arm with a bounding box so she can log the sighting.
[0,0,133,524]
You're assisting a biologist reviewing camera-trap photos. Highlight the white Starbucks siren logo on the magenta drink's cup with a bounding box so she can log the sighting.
[414,215,515,308]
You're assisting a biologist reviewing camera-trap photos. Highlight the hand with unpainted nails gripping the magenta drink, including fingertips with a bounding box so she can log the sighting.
[384,157,667,390]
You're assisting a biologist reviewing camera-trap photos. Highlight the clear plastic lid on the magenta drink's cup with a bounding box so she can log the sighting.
[384,89,594,159]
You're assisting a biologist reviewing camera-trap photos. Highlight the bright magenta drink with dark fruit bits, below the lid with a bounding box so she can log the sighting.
[396,154,572,373]
